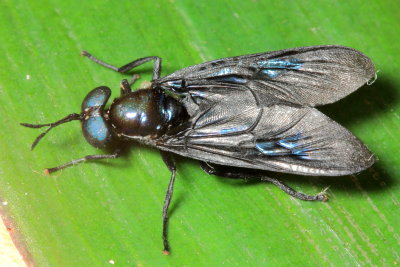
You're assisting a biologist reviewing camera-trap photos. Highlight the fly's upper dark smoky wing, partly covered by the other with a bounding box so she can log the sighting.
[155,46,375,106]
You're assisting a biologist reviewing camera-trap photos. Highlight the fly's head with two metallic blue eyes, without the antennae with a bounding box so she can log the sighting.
[82,86,112,148]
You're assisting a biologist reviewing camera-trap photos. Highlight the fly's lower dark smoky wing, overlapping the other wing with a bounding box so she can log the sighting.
[158,85,374,176]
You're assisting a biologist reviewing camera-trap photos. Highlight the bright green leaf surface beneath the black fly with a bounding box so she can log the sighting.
[0,0,400,266]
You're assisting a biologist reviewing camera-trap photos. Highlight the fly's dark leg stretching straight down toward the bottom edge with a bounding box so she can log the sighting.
[161,151,176,255]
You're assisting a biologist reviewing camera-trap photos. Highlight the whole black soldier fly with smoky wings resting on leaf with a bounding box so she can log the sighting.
[21,45,375,254]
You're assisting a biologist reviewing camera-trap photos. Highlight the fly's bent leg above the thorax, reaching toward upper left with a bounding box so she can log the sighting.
[81,51,161,80]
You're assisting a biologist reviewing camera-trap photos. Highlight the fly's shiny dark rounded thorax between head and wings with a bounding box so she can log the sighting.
[108,89,184,137]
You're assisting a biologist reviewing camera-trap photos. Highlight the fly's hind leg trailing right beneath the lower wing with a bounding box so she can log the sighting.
[201,162,328,201]
